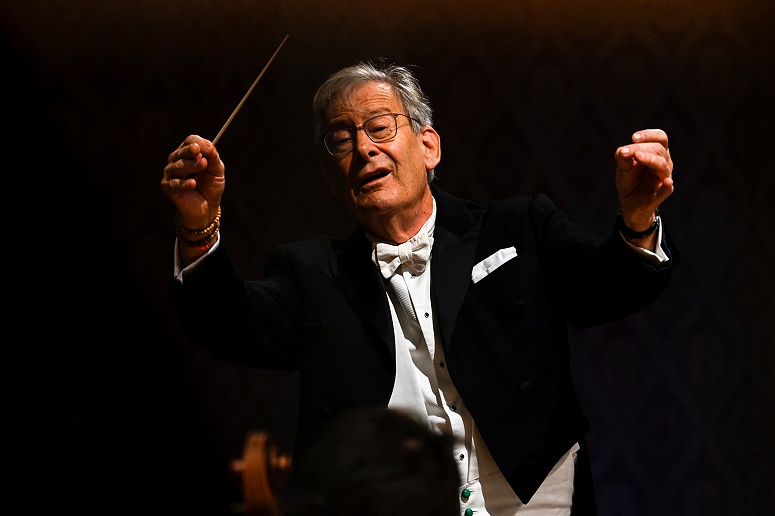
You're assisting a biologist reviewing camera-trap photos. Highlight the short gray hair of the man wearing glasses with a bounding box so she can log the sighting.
[312,62,435,182]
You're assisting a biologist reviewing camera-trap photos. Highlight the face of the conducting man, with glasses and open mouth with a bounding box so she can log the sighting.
[322,82,441,239]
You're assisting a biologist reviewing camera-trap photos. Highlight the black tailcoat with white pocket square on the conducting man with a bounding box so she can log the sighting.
[171,185,677,505]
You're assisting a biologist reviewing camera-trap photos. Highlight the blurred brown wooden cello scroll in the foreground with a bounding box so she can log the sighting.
[231,432,293,516]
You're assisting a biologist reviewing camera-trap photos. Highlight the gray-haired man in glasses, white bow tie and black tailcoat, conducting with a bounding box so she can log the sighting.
[161,63,677,516]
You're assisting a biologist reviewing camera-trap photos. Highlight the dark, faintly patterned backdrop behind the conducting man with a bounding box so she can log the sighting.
[7,0,775,516]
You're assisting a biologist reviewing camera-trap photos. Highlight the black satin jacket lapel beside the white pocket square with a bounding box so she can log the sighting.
[431,189,481,349]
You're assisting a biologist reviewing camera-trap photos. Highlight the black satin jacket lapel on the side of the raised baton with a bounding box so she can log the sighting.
[333,230,395,359]
